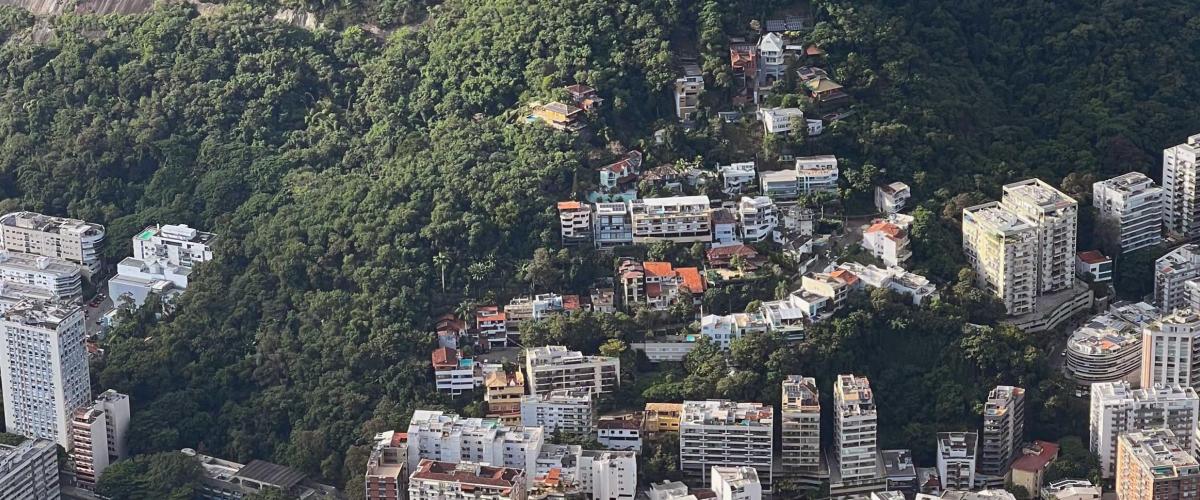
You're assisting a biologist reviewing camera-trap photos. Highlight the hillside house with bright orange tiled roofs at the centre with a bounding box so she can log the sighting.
[617,258,706,311]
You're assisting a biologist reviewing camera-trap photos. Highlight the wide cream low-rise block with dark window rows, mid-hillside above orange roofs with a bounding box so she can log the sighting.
[629,195,713,243]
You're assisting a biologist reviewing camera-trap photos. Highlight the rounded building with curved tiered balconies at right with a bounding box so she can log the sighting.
[1066,302,1158,385]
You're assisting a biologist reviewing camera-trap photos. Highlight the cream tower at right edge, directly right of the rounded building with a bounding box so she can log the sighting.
[1141,309,1200,387]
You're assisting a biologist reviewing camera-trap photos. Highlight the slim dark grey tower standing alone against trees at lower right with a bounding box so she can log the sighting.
[978,385,1025,477]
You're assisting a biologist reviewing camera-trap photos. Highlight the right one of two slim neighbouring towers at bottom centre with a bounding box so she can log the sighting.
[829,374,880,483]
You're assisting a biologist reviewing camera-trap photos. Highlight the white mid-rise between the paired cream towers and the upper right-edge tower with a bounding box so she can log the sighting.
[1092,171,1164,253]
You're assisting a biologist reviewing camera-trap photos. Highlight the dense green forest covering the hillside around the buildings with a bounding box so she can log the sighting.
[0,0,1200,492]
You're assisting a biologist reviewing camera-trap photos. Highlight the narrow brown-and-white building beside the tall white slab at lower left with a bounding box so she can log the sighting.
[71,388,130,489]
